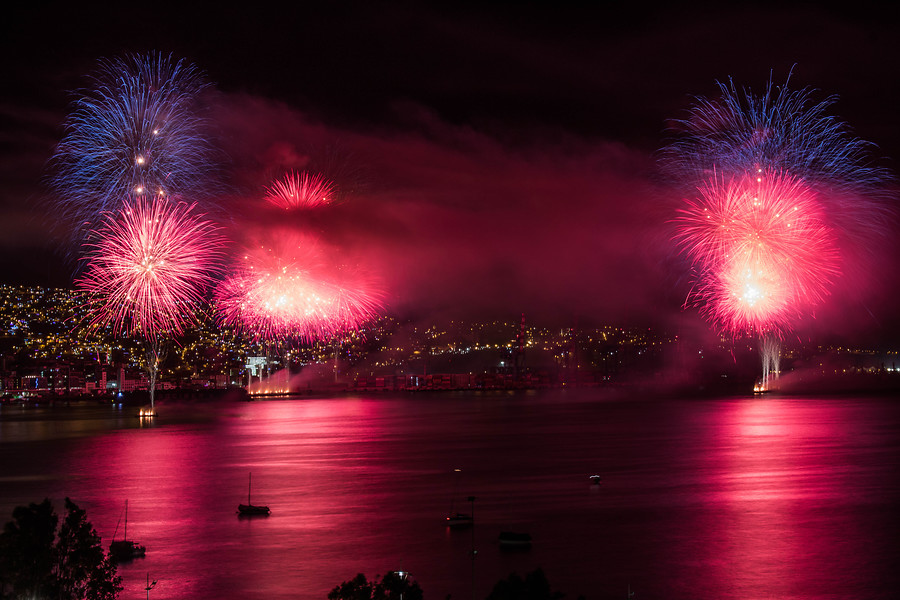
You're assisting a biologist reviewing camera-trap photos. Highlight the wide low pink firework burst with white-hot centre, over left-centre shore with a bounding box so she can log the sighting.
[216,233,382,341]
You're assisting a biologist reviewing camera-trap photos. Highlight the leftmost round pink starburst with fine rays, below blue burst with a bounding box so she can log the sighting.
[76,197,222,340]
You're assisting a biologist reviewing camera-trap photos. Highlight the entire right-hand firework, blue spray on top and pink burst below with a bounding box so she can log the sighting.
[662,74,893,346]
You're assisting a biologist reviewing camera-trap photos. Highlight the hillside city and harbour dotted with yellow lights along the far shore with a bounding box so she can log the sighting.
[0,285,900,402]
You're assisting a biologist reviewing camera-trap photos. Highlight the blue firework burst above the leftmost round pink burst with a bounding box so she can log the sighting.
[51,53,218,242]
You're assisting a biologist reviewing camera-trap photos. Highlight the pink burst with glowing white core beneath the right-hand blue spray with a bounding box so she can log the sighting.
[676,170,840,337]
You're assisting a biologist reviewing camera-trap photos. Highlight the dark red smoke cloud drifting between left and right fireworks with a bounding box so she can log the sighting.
[207,94,680,324]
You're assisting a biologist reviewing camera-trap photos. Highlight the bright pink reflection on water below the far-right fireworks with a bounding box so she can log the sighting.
[708,397,876,598]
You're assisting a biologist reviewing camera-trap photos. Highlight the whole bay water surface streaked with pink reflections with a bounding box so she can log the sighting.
[0,392,900,600]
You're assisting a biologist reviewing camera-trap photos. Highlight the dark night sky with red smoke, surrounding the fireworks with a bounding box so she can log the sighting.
[0,2,900,342]
